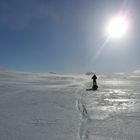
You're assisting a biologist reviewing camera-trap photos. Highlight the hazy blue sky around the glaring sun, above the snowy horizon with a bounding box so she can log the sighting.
[0,0,140,73]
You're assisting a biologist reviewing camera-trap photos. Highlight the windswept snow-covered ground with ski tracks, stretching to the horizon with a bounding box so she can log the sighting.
[0,70,140,140]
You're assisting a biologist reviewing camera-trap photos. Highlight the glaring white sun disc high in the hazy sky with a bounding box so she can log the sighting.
[107,16,129,38]
